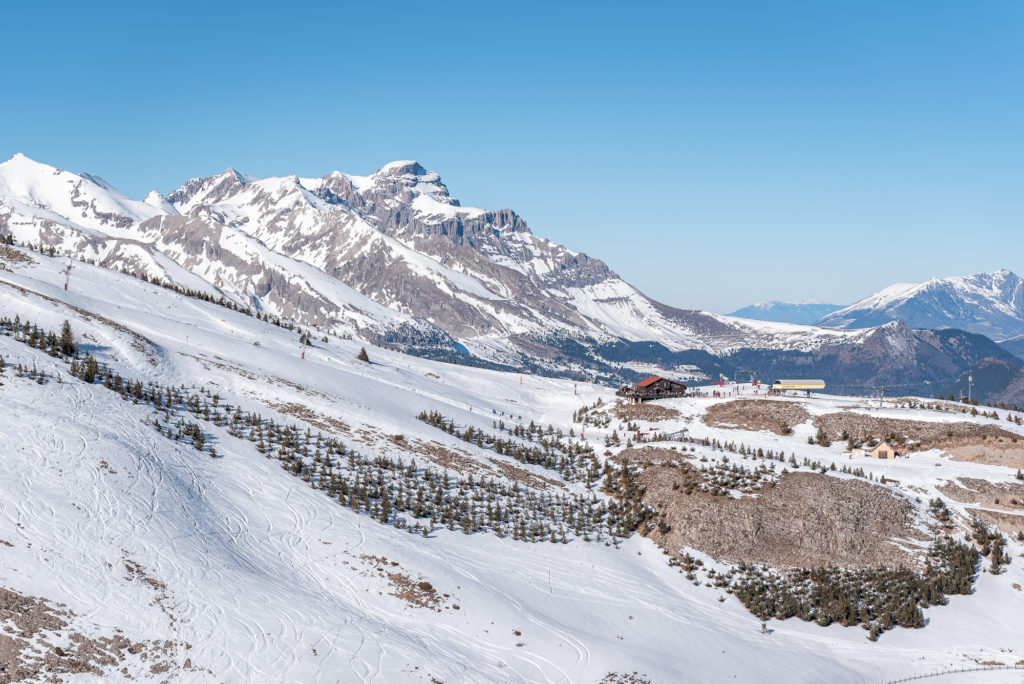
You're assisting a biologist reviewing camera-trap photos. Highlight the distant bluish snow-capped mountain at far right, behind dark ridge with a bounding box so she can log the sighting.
[818,269,1024,342]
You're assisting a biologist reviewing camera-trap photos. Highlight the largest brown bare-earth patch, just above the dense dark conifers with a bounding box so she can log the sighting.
[637,464,925,568]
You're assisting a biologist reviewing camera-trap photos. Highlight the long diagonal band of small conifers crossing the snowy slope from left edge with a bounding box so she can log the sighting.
[0,313,645,543]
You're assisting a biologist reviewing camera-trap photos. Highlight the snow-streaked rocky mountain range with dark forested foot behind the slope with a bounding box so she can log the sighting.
[0,150,1007,394]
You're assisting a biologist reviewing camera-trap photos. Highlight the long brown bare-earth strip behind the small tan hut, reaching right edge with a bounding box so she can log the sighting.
[814,412,1024,465]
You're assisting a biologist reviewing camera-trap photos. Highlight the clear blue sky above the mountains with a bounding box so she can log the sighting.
[0,0,1024,312]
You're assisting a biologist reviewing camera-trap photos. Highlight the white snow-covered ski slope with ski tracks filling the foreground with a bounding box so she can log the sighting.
[0,249,1024,682]
